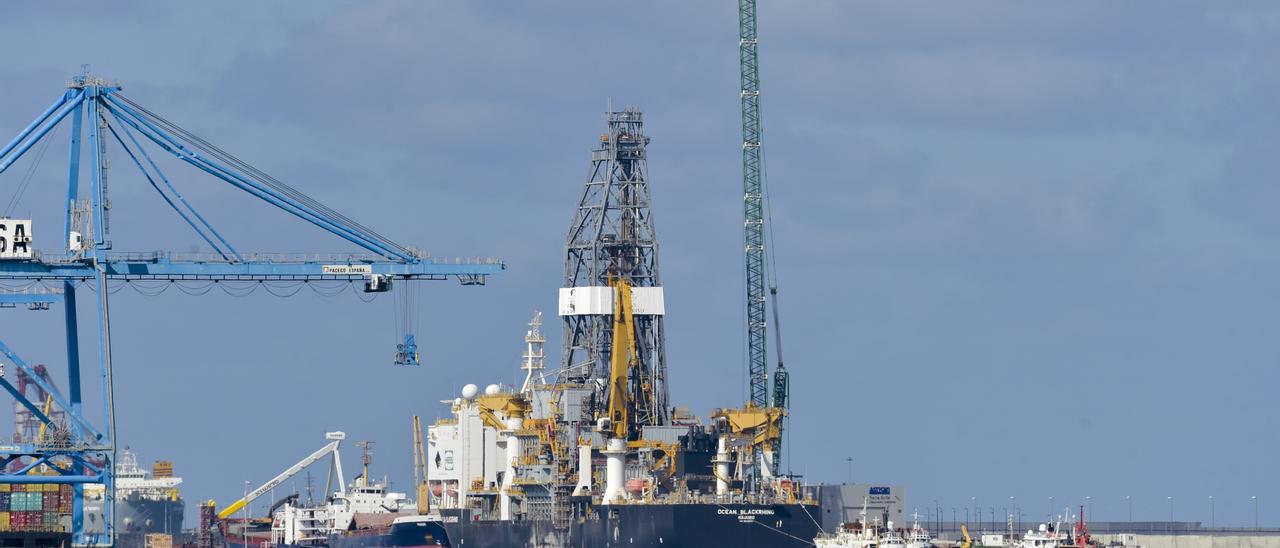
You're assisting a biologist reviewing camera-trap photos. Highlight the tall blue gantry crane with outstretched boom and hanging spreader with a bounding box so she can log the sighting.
[0,67,504,545]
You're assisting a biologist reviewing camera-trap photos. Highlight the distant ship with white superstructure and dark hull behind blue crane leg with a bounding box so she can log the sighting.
[115,448,184,545]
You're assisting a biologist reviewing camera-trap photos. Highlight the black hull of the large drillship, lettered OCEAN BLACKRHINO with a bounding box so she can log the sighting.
[432,503,819,548]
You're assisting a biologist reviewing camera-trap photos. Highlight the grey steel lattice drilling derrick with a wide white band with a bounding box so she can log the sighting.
[559,109,669,434]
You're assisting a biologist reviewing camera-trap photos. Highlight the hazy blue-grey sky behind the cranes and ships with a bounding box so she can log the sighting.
[0,0,1280,525]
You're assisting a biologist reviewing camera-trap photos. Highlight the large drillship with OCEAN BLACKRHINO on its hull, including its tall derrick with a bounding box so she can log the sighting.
[409,109,820,548]
